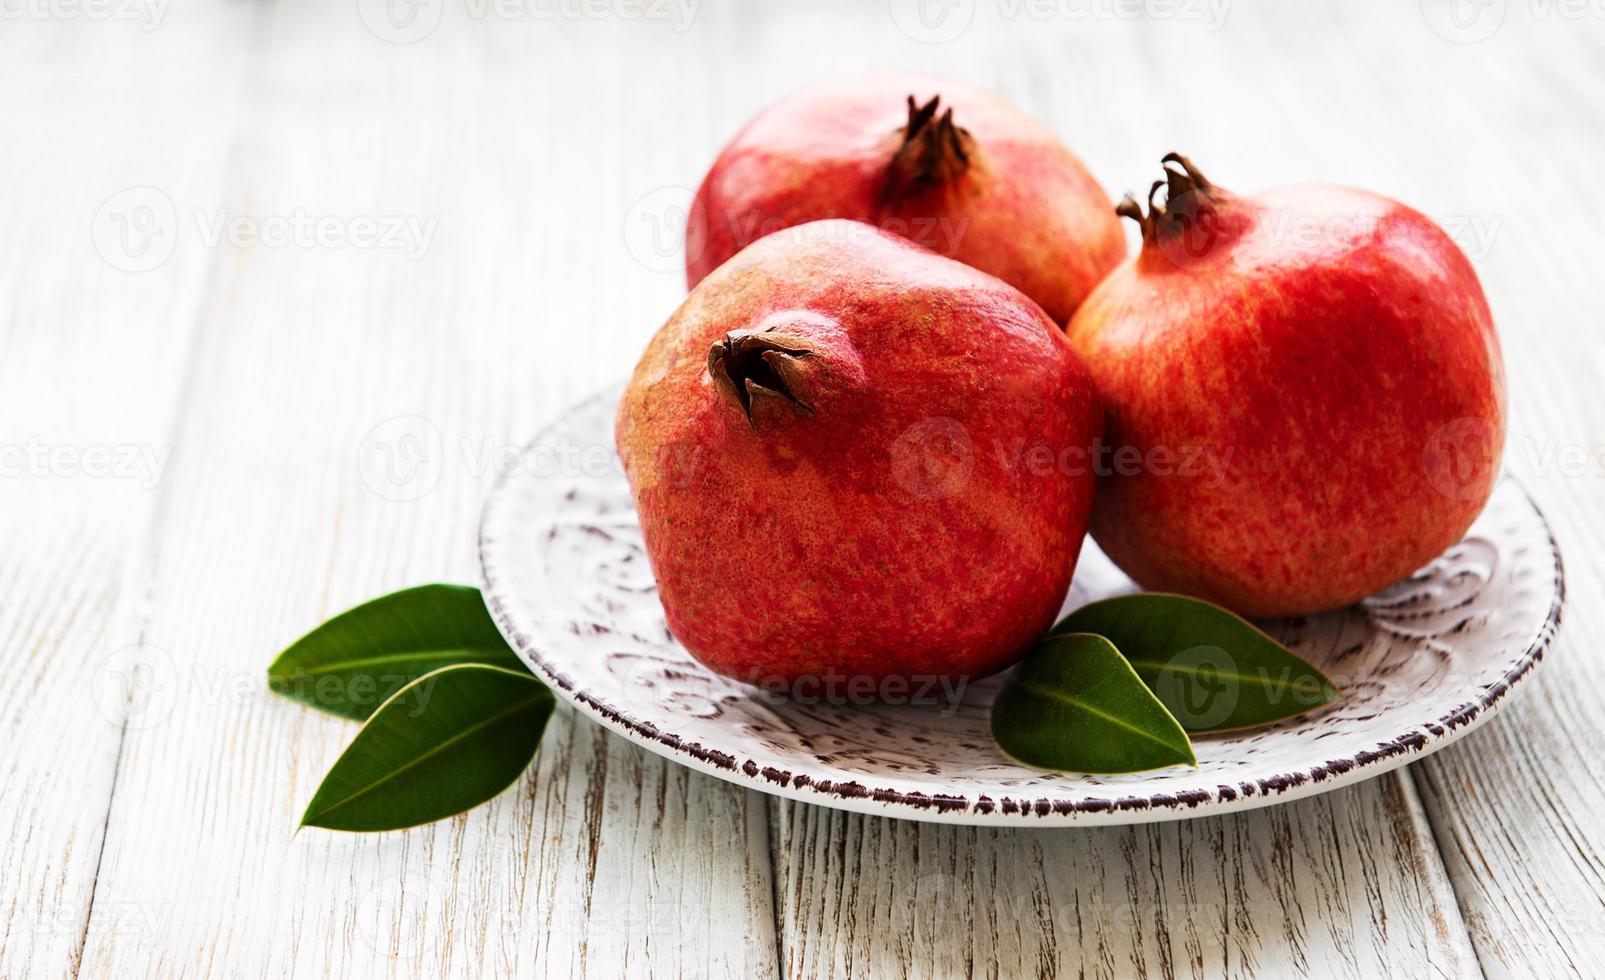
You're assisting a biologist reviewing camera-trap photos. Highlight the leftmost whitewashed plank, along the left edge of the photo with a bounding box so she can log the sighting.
[0,5,256,977]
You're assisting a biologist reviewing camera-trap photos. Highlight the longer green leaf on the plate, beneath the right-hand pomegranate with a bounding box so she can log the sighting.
[1053,592,1343,731]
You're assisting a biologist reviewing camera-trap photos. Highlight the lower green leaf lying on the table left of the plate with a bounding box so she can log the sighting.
[302,664,552,831]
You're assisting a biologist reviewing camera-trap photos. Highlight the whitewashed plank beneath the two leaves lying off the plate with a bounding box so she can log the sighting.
[70,0,775,977]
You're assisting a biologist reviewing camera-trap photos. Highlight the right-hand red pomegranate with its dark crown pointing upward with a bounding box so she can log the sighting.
[1067,154,1505,616]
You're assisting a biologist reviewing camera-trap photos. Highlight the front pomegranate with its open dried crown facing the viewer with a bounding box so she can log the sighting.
[616,221,1103,689]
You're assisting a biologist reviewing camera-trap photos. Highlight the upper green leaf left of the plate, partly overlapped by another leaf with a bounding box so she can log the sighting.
[268,585,530,722]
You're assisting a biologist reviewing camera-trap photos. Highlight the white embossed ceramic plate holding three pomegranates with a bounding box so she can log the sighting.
[480,390,1563,824]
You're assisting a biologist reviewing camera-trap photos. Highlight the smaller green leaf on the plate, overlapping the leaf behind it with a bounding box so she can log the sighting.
[992,634,1197,773]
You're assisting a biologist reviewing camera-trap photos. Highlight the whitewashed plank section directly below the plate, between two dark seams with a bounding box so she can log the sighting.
[774,776,1477,977]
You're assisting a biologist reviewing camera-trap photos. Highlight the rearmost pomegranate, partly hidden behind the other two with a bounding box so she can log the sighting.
[685,74,1125,324]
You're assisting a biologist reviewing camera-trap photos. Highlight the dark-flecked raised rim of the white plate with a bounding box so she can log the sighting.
[477,385,1566,826]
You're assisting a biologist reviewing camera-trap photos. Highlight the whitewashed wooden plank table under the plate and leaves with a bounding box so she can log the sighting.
[0,0,1605,978]
